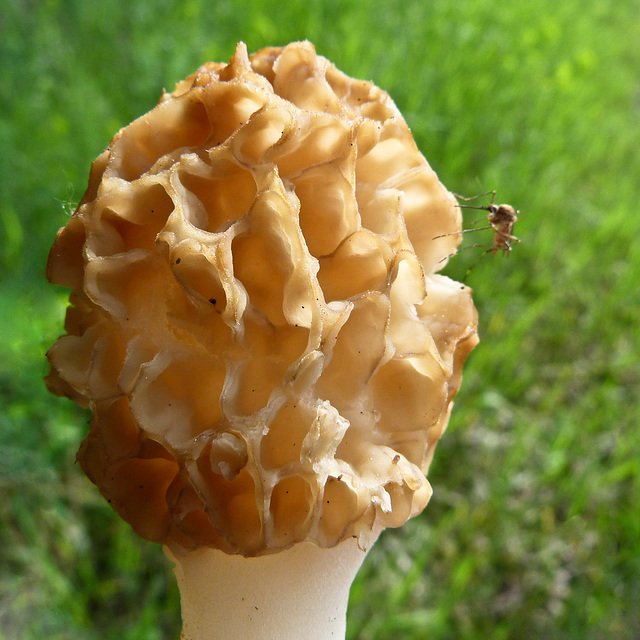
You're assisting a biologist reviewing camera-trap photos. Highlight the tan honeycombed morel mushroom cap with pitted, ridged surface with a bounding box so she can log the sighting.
[47,42,477,555]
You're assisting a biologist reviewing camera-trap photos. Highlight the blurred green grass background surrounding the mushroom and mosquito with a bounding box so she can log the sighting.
[0,0,640,640]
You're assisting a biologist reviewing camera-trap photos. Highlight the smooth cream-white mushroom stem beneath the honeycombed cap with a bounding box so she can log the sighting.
[165,536,377,640]
